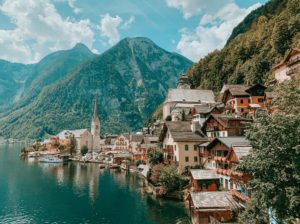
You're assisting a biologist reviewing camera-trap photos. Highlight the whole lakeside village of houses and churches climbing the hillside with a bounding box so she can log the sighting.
[24,49,300,223]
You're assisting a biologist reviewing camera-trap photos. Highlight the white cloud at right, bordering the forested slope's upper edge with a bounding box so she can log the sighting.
[172,0,261,61]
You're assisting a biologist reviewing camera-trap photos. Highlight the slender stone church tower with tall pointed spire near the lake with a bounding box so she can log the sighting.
[91,95,100,150]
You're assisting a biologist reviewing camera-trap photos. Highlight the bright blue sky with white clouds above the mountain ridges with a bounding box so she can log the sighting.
[0,0,268,64]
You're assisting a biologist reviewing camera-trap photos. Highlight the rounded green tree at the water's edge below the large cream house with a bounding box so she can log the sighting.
[159,165,181,192]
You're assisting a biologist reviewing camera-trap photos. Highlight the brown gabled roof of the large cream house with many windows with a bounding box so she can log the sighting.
[159,121,207,142]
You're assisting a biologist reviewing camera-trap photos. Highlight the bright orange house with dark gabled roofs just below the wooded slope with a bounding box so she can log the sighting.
[221,84,266,115]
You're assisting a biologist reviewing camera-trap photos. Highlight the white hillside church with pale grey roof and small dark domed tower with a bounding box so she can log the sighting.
[163,74,215,121]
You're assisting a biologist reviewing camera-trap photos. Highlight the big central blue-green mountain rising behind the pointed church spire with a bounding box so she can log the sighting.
[0,37,192,138]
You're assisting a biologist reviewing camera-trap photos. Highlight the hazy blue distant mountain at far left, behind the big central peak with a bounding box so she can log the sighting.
[0,44,95,112]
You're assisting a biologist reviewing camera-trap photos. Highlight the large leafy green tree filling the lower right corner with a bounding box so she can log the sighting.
[237,111,300,223]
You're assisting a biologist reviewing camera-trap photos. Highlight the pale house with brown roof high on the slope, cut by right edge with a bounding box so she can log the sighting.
[272,48,300,83]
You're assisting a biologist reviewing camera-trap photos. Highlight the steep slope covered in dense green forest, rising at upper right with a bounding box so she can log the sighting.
[188,0,300,91]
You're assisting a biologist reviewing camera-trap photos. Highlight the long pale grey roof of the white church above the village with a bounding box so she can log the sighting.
[165,89,215,103]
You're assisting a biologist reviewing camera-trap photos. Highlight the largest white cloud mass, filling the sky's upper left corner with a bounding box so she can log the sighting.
[0,0,94,63]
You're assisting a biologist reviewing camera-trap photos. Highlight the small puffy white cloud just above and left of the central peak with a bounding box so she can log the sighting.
[98,13,135,45]
